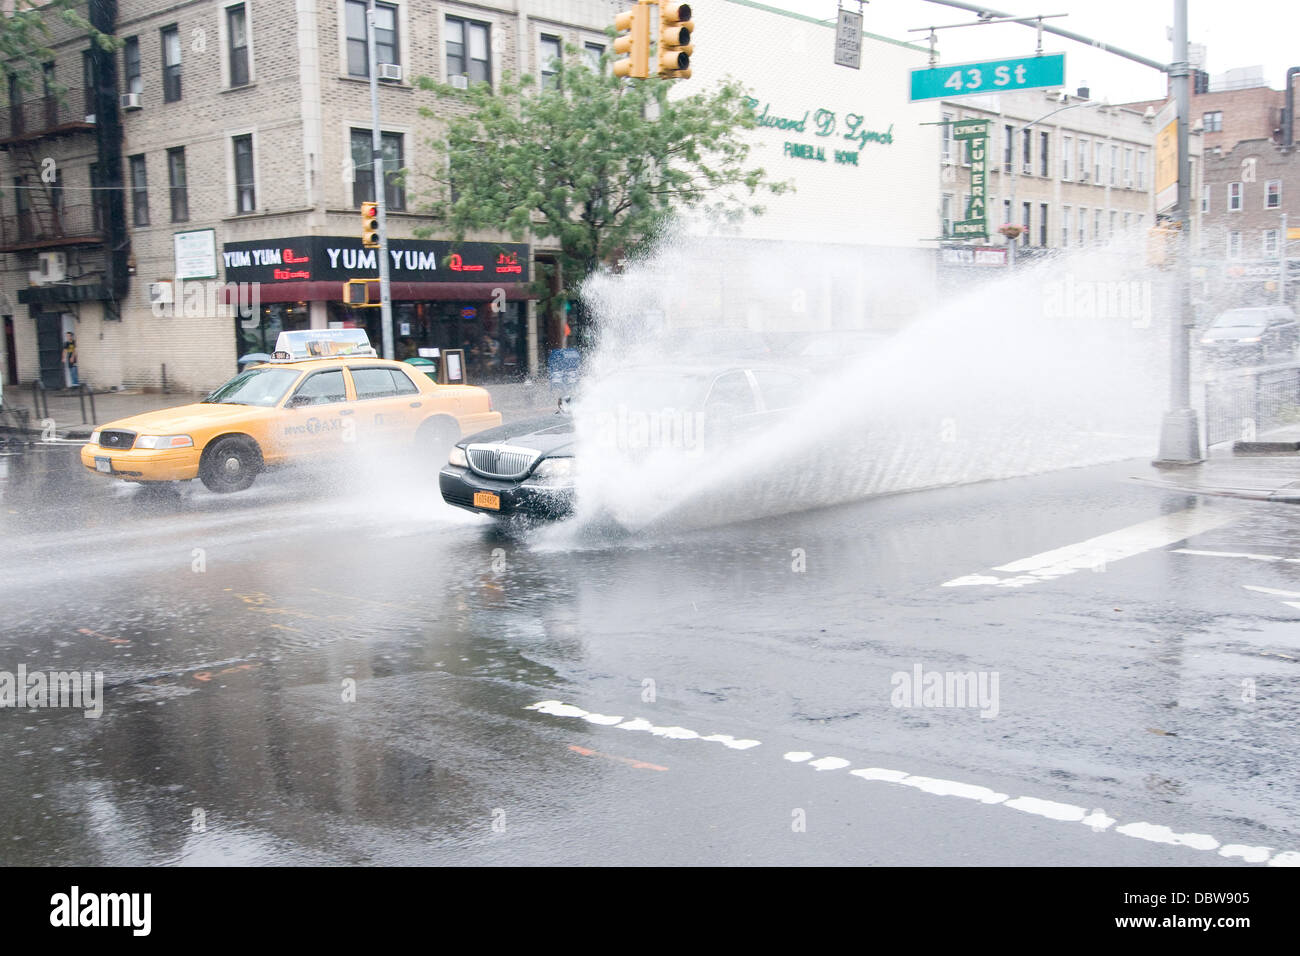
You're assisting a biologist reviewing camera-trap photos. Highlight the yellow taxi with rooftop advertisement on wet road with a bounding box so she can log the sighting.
[81,330,501,492]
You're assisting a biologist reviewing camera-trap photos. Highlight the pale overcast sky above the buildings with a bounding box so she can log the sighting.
[764,0,1300,103]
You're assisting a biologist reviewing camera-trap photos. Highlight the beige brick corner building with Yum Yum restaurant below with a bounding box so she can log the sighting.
[0,0,620,390]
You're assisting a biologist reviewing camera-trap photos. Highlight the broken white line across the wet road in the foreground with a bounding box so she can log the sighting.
[525,700,1300,866]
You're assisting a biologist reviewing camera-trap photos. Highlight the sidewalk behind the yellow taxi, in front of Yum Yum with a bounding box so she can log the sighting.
[3,380,560,441]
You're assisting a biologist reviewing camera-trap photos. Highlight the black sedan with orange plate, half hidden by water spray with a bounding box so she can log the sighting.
[438,365,810,519]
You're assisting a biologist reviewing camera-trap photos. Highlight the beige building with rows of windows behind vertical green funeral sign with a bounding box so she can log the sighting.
[940,90,1200,267]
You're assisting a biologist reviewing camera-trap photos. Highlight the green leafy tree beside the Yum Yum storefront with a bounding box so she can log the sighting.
[420,55,789,323]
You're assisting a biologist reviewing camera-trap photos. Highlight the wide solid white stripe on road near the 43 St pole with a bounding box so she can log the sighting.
[943,507,1236,588]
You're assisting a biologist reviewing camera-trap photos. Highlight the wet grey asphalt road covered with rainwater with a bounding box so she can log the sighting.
[0,446,1300,865]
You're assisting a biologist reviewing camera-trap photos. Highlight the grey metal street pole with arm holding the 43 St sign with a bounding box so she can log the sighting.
[927,0,1201,464]
